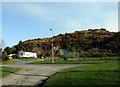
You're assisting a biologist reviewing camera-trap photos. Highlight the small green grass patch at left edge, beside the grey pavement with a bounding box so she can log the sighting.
[0,66,21,77]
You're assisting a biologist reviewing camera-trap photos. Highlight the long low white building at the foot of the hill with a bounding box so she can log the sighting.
[19,51,37,58]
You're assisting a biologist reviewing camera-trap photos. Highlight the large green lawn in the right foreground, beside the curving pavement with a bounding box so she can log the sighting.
[43,60,120,87]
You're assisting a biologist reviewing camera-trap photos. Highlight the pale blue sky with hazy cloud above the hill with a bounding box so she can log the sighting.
[2,2,118,46]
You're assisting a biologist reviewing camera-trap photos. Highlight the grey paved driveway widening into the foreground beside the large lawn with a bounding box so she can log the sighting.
[2,61,89,85]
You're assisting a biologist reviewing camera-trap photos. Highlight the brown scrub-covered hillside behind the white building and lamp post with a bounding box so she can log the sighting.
[10,28,120,57]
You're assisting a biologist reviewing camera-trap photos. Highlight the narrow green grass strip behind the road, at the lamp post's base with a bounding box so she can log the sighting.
[27,57,118,64]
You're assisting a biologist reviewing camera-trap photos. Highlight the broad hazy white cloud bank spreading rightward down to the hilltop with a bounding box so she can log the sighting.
[3,2,117,31]
